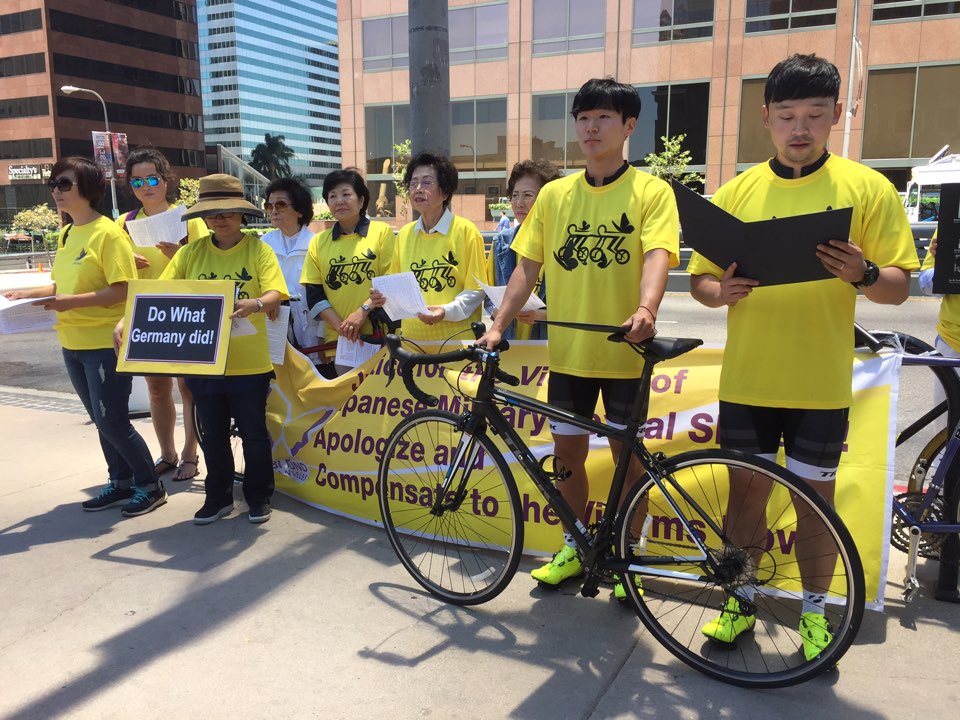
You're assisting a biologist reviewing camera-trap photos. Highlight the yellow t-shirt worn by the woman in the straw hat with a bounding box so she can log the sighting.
[160,233,290,375]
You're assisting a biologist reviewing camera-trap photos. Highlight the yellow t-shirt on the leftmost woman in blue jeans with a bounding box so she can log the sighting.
[50,215,137,350]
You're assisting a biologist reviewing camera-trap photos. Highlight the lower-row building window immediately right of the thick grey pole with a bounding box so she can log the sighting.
[450,98,507,172]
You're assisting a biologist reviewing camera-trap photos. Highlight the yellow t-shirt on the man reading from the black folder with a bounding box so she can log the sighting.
[687,155,919,410]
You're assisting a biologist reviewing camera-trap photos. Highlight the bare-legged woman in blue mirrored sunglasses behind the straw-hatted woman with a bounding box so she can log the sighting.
[117,148,207,481]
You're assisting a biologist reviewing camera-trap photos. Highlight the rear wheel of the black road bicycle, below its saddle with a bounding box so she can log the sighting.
[617,450,865,688]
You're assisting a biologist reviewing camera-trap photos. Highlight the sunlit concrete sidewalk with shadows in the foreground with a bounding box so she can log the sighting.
[0,392,960,720]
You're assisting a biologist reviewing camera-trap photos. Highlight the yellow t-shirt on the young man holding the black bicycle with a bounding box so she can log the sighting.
[511,167,680,378]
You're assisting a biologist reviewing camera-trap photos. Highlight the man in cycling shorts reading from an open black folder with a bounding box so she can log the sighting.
[688,55,918,661]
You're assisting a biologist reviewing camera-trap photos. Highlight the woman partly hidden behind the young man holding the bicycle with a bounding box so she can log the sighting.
[487,160,563,340]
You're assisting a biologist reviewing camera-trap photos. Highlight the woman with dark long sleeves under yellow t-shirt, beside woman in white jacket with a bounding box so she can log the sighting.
[300,168,395,375]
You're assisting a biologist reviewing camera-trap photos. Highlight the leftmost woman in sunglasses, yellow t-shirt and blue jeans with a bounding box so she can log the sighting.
[6,157,167,516]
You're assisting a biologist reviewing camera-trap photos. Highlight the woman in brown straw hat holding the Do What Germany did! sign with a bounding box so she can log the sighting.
[141,174,288,525]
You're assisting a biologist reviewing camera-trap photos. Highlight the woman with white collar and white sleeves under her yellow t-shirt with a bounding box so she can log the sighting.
[370,152,486,340]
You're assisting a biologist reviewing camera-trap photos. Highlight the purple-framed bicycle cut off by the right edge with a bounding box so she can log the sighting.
[857,326,960,603]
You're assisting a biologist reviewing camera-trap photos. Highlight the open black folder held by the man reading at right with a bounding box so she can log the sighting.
[672,180,853,286]
